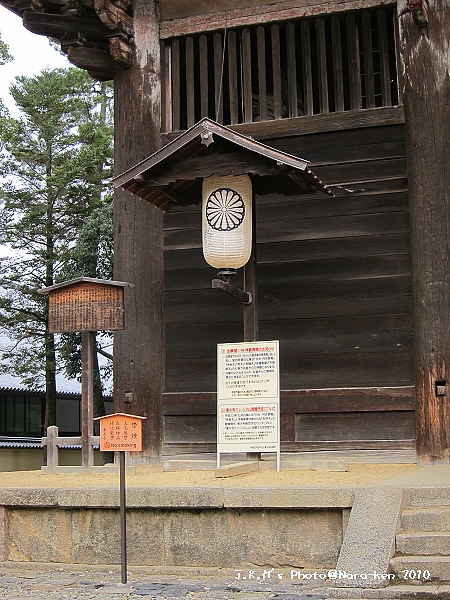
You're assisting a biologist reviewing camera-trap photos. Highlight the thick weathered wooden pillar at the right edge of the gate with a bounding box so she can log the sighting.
[398,0,450,465]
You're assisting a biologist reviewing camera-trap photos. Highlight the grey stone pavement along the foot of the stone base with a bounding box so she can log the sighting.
[0,563,327,600]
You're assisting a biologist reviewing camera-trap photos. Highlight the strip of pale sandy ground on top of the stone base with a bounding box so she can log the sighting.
[0,463,418,488]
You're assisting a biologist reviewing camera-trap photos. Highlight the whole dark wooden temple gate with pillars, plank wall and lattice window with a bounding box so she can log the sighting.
[0,0,450,464]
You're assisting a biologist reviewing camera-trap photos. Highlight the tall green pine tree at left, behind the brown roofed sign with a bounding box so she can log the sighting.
[0,68,112,436]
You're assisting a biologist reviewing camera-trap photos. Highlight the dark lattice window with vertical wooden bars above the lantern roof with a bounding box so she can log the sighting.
[163,9,399,131]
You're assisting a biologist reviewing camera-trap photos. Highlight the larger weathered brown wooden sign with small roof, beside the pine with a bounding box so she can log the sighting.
[39,277,131,333]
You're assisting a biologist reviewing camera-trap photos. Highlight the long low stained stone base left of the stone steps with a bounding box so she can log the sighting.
[0,487,353,571]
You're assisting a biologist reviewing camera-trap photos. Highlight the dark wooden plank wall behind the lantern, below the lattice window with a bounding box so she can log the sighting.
[164,119,414,451]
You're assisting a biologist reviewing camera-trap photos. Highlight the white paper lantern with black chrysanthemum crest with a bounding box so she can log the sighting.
[202,175,252,270]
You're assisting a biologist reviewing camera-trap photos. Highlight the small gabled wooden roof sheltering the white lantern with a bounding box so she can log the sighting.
[113,117,333,211]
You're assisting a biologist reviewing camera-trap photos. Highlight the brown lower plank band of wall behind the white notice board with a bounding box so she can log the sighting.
[163,386,414,454]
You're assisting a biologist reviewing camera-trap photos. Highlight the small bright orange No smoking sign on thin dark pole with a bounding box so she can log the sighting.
[94,413,147,452]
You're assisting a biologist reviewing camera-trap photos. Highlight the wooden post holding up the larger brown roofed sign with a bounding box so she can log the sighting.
[81,331,94,473]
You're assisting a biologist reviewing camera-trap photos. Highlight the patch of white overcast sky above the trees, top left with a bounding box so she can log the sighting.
[0,6,71,116]
